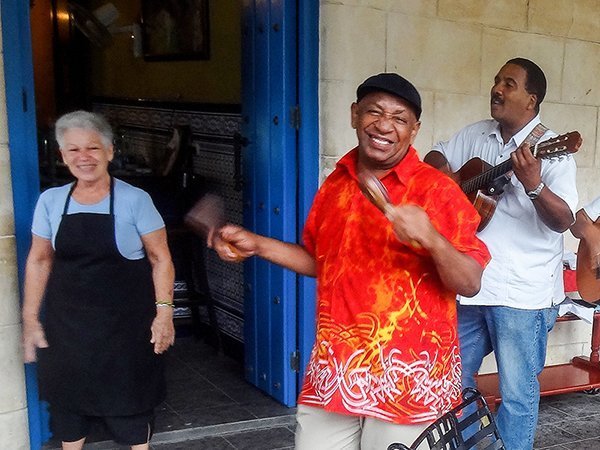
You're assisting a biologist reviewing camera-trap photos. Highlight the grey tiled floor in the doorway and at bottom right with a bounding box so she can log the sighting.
[45,337,600,450]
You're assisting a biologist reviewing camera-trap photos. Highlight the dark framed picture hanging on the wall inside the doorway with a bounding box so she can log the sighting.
[142,0,210,61]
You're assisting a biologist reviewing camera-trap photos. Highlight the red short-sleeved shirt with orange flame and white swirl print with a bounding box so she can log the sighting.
[298,147,490,424]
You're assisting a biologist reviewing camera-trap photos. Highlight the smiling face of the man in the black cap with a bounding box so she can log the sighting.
[351,91,421,173]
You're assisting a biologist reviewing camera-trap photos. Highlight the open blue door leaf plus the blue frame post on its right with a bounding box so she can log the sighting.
[242,0,318,406]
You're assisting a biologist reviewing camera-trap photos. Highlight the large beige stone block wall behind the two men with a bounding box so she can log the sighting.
[319,0,600,370]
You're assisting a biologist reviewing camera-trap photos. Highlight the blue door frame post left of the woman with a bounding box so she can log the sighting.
[1,0,50,450]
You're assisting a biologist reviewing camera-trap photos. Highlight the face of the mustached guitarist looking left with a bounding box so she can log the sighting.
[490,64,537,137]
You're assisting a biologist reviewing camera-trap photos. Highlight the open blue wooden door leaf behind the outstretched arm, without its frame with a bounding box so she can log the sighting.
[242,0,298,406]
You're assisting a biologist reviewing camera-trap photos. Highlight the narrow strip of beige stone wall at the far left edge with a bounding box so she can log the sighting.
[0,8,29,450]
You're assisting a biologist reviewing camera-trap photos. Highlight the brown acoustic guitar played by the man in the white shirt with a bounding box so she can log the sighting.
[449,131,582,231]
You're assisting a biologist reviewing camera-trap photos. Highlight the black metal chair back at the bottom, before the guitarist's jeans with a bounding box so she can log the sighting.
[387,388,505,450]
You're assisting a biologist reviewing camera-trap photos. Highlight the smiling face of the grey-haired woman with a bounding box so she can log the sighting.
[60,128,113,183]
